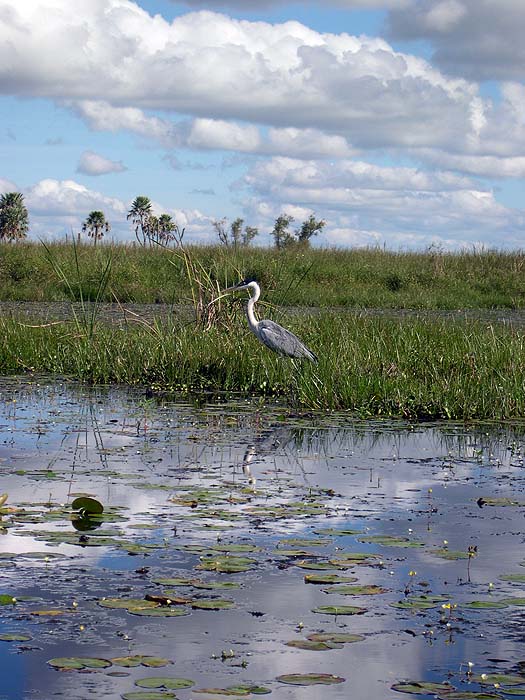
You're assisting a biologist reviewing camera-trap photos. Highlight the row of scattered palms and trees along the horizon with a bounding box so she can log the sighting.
[0,192,326,250]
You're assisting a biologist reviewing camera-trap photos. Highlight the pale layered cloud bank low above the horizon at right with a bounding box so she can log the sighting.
[244,158,525,248]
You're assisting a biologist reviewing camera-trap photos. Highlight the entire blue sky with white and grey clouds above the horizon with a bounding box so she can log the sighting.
[0,0,525,250]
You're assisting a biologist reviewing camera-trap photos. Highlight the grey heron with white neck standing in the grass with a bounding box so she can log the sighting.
[220,279,317,362]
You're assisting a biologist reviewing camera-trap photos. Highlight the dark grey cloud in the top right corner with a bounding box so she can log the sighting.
[389,0,525,80]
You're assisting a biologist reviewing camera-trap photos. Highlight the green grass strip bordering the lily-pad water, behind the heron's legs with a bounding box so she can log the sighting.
[0,313,525,419]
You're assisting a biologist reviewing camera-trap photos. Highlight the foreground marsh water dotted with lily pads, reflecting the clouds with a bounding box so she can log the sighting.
[0,379,525,700]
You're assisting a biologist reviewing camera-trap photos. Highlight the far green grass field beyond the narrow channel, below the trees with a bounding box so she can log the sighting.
[0,243,525,309]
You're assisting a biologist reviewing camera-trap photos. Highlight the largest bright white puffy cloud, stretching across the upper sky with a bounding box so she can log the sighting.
[0,0,484,152]
